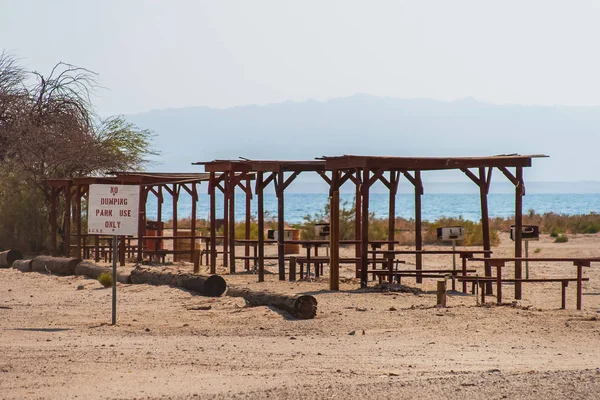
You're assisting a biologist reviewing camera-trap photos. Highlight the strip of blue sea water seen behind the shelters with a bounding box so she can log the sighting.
[146,192,600,224]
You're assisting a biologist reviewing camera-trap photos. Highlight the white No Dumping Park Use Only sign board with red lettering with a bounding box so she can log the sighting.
[88,185,140,236]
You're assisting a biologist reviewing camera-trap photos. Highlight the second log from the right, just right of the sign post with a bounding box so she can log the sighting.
[131,267,227,297]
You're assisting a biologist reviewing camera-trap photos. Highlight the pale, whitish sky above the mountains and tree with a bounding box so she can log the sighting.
[0,0,600,115]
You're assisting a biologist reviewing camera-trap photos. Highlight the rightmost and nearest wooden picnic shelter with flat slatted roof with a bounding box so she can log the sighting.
[322,154,545,298]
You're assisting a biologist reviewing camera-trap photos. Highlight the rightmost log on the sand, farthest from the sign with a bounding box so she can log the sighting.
[227,287,317,319]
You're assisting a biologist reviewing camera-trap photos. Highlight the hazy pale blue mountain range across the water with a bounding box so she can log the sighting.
[127,95,600,193]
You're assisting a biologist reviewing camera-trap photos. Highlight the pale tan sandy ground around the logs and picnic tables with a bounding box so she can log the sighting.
[0,235,600,400]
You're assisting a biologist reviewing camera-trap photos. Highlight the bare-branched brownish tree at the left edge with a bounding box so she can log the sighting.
[0,52,156,247]
